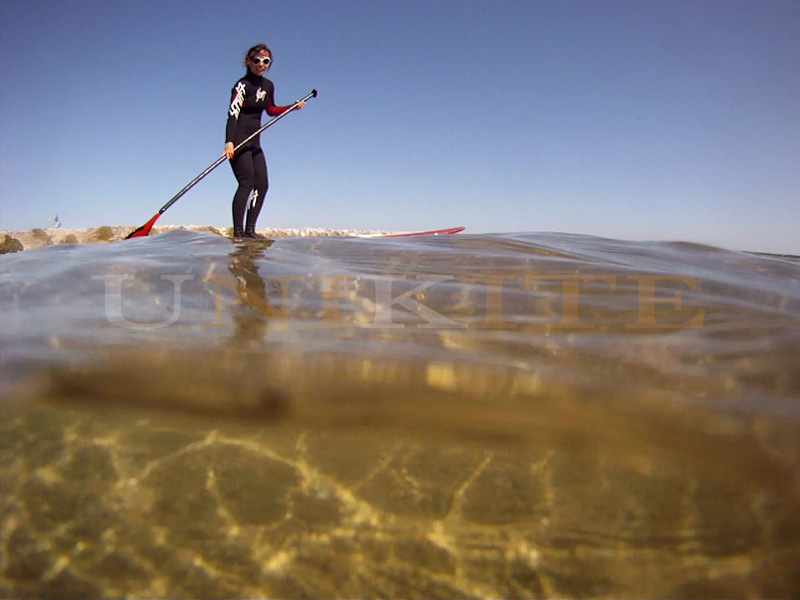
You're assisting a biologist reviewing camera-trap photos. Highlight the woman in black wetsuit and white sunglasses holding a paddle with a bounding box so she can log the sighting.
[224,44,305,238]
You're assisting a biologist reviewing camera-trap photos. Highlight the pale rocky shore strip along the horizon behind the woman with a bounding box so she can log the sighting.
[0,225,387,254]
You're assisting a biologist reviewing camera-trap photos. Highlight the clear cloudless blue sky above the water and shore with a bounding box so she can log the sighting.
[0,0,800,254]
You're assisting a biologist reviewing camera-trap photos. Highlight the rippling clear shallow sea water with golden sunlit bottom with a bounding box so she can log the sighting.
[0,231,800,597]
